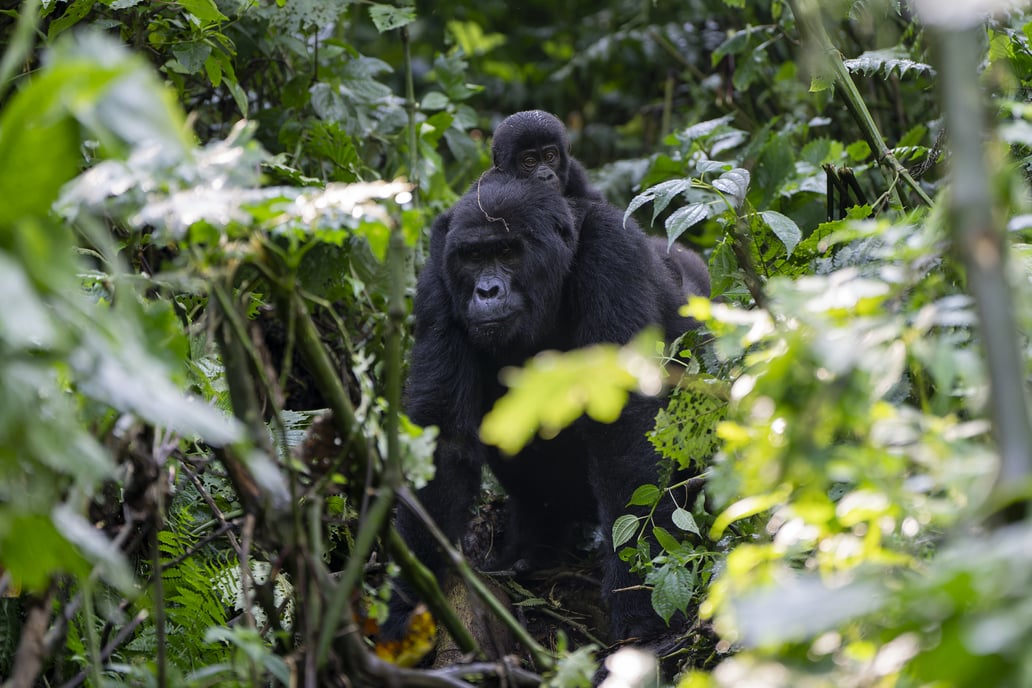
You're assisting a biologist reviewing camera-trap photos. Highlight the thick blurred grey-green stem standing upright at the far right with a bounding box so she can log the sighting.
[940,27,1032,509]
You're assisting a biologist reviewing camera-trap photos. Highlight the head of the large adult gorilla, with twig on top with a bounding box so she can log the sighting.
[444,174,577,354]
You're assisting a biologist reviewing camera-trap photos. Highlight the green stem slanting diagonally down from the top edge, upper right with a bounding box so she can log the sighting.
[788,0,932,207]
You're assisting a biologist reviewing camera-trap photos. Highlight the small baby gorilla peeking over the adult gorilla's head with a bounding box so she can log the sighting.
[491,110,603,201]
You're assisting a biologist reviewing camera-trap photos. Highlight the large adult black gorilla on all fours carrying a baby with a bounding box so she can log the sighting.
[385,172,705,637]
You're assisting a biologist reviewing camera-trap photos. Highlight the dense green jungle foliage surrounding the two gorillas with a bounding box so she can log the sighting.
[0,0,1032,687]
